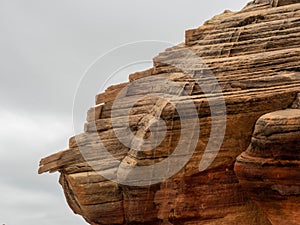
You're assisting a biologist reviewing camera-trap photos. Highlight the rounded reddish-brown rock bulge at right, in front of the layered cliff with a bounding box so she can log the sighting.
[235,109,300,224]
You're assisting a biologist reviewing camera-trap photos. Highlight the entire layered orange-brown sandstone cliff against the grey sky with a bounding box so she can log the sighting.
[39,0,300,225]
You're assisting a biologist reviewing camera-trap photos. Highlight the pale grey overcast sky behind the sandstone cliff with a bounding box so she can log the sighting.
[0,0,248,225]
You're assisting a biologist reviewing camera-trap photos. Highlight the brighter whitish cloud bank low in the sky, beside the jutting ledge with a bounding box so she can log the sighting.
[0,109,85,225]
